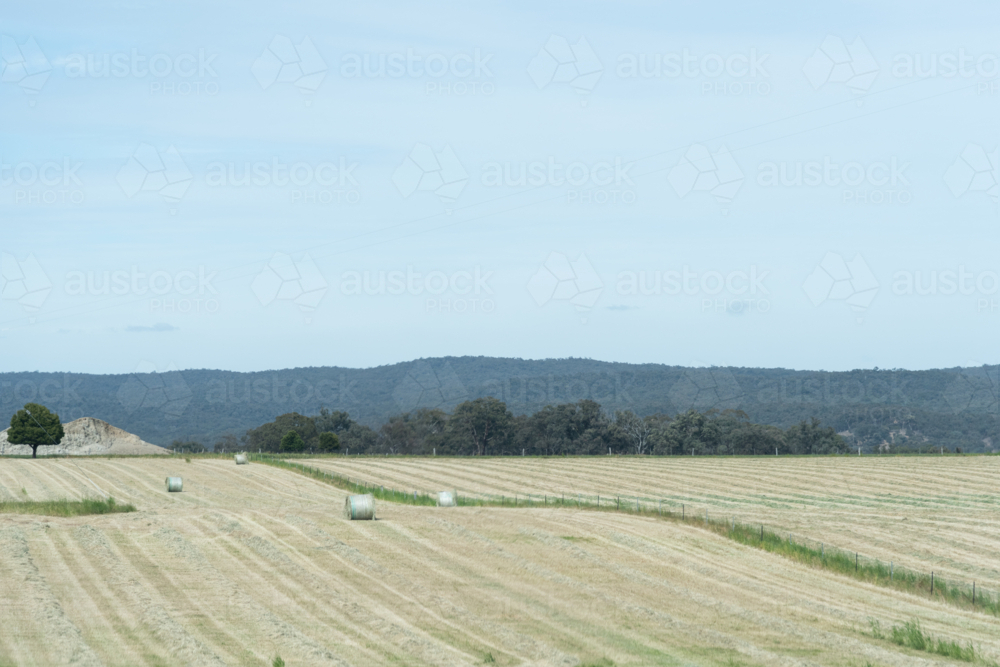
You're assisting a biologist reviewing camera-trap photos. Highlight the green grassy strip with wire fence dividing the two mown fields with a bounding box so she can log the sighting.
[251,453,1000,616]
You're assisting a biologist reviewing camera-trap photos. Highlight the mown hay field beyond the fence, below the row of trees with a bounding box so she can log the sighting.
[305,456,1000,592]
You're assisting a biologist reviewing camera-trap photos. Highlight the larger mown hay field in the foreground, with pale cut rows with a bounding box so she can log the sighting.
[0,458,1000,667]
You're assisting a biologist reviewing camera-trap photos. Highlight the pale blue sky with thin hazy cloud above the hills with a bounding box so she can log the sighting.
[0,2,1000,373]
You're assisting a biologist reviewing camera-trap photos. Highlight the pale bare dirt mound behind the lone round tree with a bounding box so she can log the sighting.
[0,417,170,456]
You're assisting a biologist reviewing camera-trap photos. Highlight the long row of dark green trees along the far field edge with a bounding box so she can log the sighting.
[188,397,850,456]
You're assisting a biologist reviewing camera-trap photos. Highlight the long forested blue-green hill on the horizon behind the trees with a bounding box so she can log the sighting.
[0,357,1000,451]
